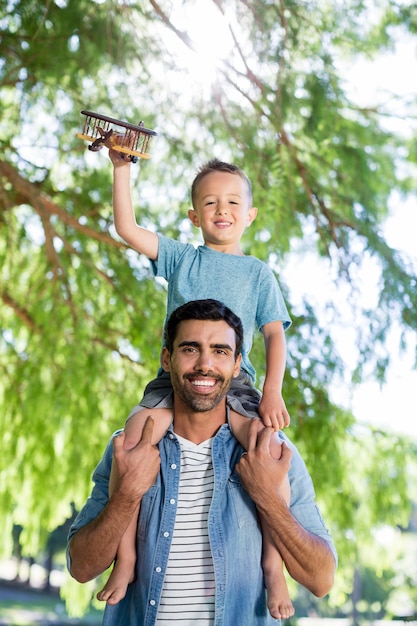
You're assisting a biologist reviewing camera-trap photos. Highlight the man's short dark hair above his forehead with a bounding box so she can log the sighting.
[165,299,243,358]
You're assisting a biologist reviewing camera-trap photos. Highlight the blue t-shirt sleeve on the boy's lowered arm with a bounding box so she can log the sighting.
[256,266,291,330]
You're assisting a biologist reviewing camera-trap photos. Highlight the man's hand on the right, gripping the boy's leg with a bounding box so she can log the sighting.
[236,420,292,506]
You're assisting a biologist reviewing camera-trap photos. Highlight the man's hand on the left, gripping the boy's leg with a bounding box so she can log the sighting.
[113,415,161,502]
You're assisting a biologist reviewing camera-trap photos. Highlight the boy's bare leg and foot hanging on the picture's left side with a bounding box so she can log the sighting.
[97,409,172,604]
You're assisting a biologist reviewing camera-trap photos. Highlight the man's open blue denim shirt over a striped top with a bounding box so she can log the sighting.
[68,424,336,626]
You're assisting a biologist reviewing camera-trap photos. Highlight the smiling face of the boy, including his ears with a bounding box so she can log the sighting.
[188,172,258,251]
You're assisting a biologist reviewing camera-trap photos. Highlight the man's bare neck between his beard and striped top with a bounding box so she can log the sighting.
[173,397,226,445]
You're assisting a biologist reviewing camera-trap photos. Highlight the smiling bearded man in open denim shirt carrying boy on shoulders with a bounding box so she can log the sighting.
[68,300,336,626]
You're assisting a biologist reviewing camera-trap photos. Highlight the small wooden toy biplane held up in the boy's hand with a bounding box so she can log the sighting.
[77,111,158,163]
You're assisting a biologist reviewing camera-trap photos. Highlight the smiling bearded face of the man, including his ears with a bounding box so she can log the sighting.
[162,320,241,412]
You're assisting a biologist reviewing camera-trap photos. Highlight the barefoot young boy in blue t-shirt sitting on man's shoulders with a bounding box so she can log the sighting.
[97,154,294,619]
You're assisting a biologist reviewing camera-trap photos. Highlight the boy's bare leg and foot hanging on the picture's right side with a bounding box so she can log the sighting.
[229,411,294,619]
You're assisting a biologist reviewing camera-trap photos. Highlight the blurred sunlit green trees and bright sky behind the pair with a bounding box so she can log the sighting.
[0,0,417,624]
